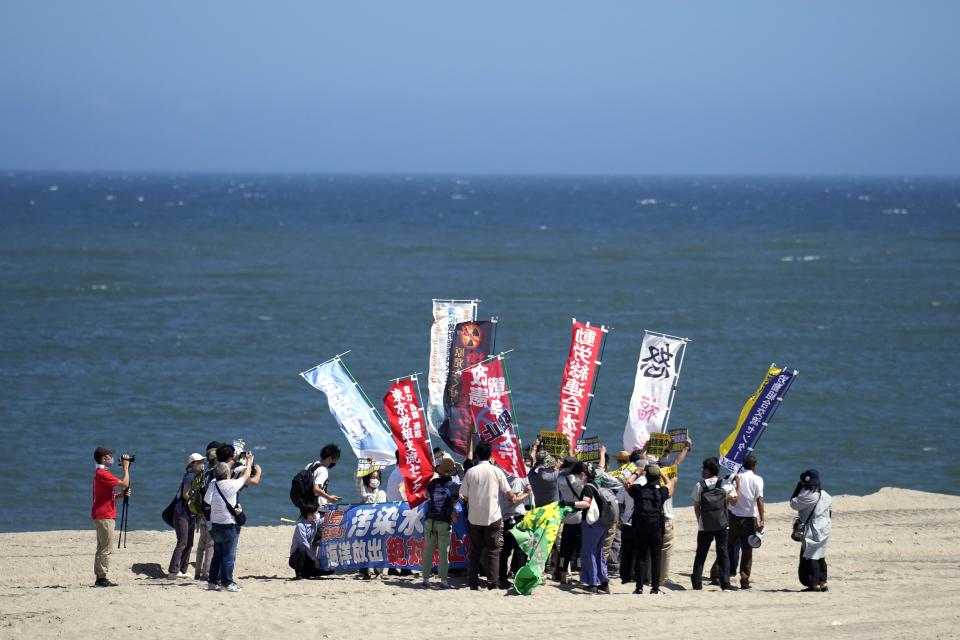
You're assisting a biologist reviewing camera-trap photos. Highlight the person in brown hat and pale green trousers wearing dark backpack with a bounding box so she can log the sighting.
[420,457,460,589]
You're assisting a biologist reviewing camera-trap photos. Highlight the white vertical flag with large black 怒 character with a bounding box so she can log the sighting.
[623,331,687,451]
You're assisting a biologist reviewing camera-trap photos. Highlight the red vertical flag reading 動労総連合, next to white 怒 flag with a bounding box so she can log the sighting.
[557,320,606,447]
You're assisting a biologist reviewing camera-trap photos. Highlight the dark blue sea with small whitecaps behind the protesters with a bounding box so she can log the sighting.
[0,172,960,530]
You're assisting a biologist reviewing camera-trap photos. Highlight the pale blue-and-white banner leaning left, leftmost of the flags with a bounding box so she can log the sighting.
[300,356,397,473]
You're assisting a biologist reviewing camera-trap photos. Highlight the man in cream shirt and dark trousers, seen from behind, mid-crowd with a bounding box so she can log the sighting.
[460,442,526,591]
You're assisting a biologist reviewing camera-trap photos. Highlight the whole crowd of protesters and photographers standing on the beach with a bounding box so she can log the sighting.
[92,438,831,596]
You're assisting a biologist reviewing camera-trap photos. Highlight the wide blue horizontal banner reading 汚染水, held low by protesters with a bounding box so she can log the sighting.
[318,502,470,573]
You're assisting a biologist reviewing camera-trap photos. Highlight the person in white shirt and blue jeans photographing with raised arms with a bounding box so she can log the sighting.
[203,452,253,593]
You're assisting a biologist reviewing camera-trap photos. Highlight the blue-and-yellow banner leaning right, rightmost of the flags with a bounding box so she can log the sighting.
[720,363,799,473]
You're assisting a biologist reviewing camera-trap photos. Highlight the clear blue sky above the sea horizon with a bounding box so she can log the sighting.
[0,0,960,175]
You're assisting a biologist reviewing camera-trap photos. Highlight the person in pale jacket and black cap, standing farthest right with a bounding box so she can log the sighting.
[790,469,833,591]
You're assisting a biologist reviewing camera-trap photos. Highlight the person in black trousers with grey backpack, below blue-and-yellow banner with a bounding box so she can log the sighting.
[690,458,737,591]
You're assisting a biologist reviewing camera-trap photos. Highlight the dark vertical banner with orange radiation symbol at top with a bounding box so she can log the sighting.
[437,318,497,456]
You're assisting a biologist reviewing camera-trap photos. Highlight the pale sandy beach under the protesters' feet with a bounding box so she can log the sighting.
[0,488,960,638]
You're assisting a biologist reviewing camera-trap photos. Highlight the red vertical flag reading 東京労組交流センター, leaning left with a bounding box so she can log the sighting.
[383,378,433,507]
